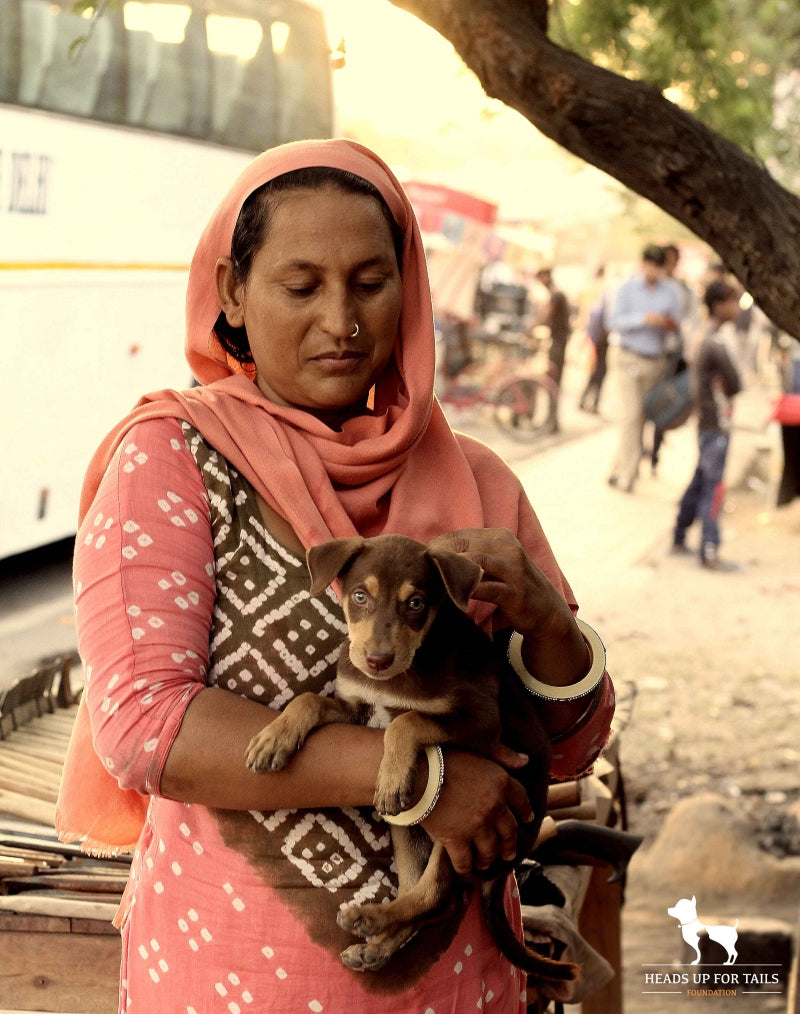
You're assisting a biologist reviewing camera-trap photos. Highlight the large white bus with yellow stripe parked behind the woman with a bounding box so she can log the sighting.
[0,0,333,559]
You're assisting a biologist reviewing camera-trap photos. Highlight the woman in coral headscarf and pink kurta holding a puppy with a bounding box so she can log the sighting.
[58,141,613,1014]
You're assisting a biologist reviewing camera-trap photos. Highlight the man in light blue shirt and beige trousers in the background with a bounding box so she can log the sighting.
[608,243,680,493]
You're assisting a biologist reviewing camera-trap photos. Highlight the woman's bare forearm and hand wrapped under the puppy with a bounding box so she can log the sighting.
[160,689,533,874]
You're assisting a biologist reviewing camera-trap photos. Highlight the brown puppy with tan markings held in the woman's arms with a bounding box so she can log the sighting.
[246,535,577,982]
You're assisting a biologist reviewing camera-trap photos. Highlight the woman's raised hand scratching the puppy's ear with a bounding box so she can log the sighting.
[431,528,573,640]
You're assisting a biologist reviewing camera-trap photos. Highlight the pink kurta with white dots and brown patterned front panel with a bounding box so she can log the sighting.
[75,419,613,1014]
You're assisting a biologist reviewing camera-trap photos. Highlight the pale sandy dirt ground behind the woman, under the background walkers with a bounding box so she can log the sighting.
[450,352,800,1014]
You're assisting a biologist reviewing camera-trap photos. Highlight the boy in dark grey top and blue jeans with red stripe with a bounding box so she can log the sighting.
[672,282,741,570]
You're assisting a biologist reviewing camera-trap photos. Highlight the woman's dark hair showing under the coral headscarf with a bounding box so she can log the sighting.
[214,165,404,363]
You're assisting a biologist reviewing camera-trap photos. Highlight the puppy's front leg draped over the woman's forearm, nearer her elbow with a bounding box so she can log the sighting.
[244,693,352,773]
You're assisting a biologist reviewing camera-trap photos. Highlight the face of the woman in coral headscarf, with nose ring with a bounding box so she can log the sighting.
[217,188,402,428]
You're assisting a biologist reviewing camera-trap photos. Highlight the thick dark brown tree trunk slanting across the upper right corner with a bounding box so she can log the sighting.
[391,0,800,338]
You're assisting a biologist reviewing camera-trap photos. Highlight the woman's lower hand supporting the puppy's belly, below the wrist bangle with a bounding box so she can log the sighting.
[423,746,533,876]
